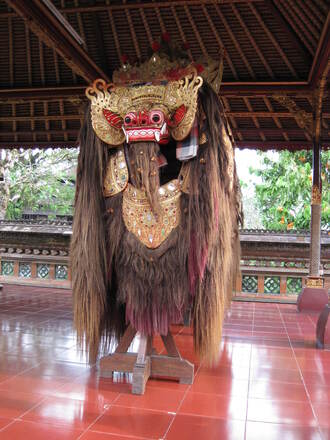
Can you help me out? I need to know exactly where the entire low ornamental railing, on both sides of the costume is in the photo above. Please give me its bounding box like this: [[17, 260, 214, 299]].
[[0, 221, 330, 302]]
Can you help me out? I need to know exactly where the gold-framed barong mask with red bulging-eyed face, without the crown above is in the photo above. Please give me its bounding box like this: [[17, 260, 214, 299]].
[[86, 67, 203, 146]]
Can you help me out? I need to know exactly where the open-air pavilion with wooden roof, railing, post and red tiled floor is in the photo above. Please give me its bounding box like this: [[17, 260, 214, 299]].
[[0, 0, 330, 440]]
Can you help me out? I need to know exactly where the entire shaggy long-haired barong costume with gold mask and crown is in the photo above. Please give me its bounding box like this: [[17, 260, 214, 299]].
[[71, 41, 241, 368]]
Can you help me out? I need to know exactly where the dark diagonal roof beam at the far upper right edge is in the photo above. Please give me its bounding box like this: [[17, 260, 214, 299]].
[[308, 12, 330, 89]]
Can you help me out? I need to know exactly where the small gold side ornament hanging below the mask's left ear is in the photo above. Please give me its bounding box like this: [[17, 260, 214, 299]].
[[103, 148, 128, 197]]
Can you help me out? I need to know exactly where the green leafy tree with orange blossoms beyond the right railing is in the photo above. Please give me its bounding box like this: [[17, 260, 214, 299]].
[[250, 151, 330, 230]]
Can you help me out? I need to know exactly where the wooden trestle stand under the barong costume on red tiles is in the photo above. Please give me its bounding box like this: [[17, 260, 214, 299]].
[[100, 326, 194, 394]]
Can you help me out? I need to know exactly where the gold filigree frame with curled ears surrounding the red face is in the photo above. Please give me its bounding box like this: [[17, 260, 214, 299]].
[[86, 68, 203, 146]]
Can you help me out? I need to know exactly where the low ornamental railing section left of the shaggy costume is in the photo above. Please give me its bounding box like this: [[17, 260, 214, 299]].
[[0, 220, 71, 288]]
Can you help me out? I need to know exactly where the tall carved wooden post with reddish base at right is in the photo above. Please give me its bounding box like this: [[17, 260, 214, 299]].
[[297, 63, 330, 311]]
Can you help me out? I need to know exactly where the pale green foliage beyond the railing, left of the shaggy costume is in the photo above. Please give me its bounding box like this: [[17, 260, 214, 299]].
[[1, 149, 78, 219]]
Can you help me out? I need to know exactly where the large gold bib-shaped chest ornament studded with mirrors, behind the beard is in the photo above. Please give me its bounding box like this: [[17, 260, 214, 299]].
[[123, 179, 181, 249]]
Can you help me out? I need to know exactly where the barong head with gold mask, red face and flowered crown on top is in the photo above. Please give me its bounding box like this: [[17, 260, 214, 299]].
[[86, 40, 221, 147]]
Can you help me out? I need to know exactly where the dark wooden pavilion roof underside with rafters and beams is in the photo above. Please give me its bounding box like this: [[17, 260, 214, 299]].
[[0, 0, 330, 149]]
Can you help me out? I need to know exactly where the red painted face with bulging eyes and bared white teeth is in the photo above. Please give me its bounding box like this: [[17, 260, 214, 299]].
[[122, 110, 170, 144]]
